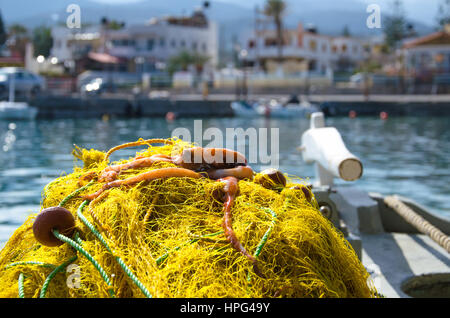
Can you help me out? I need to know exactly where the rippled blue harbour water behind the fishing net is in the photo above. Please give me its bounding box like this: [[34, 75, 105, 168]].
[[0, 117, 450, 246]]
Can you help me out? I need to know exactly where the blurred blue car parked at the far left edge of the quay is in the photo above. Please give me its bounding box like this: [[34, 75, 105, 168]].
[[0, 67, 45, 98]]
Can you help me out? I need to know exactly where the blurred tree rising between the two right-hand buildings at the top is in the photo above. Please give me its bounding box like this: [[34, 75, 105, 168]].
[[384, 0, 407, 50]]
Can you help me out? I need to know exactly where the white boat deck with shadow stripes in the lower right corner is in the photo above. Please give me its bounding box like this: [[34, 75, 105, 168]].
[[360, 232, 450, 298]]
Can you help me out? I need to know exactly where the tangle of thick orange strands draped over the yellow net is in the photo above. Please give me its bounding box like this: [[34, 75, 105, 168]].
[[36, 139, 285, 277]]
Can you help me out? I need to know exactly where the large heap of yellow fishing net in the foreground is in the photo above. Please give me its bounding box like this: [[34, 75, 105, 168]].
[[0, 139, 376, 298]]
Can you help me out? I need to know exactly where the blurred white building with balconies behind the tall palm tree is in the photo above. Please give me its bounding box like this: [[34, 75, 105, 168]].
[[246, 23, 365, 74]]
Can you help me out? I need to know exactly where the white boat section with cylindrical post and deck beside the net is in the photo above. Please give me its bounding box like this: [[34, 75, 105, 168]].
[[300, 112, 450, 298]]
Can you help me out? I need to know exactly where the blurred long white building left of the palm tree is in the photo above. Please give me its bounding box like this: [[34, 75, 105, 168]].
[[51, 9, 218, 72]]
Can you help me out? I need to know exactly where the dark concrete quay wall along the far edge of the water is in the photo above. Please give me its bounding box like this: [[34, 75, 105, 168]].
[[28, 94, 450, 119]]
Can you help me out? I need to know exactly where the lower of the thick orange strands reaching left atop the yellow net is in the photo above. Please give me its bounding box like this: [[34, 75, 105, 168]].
[[83, 167, 201, 200]]
